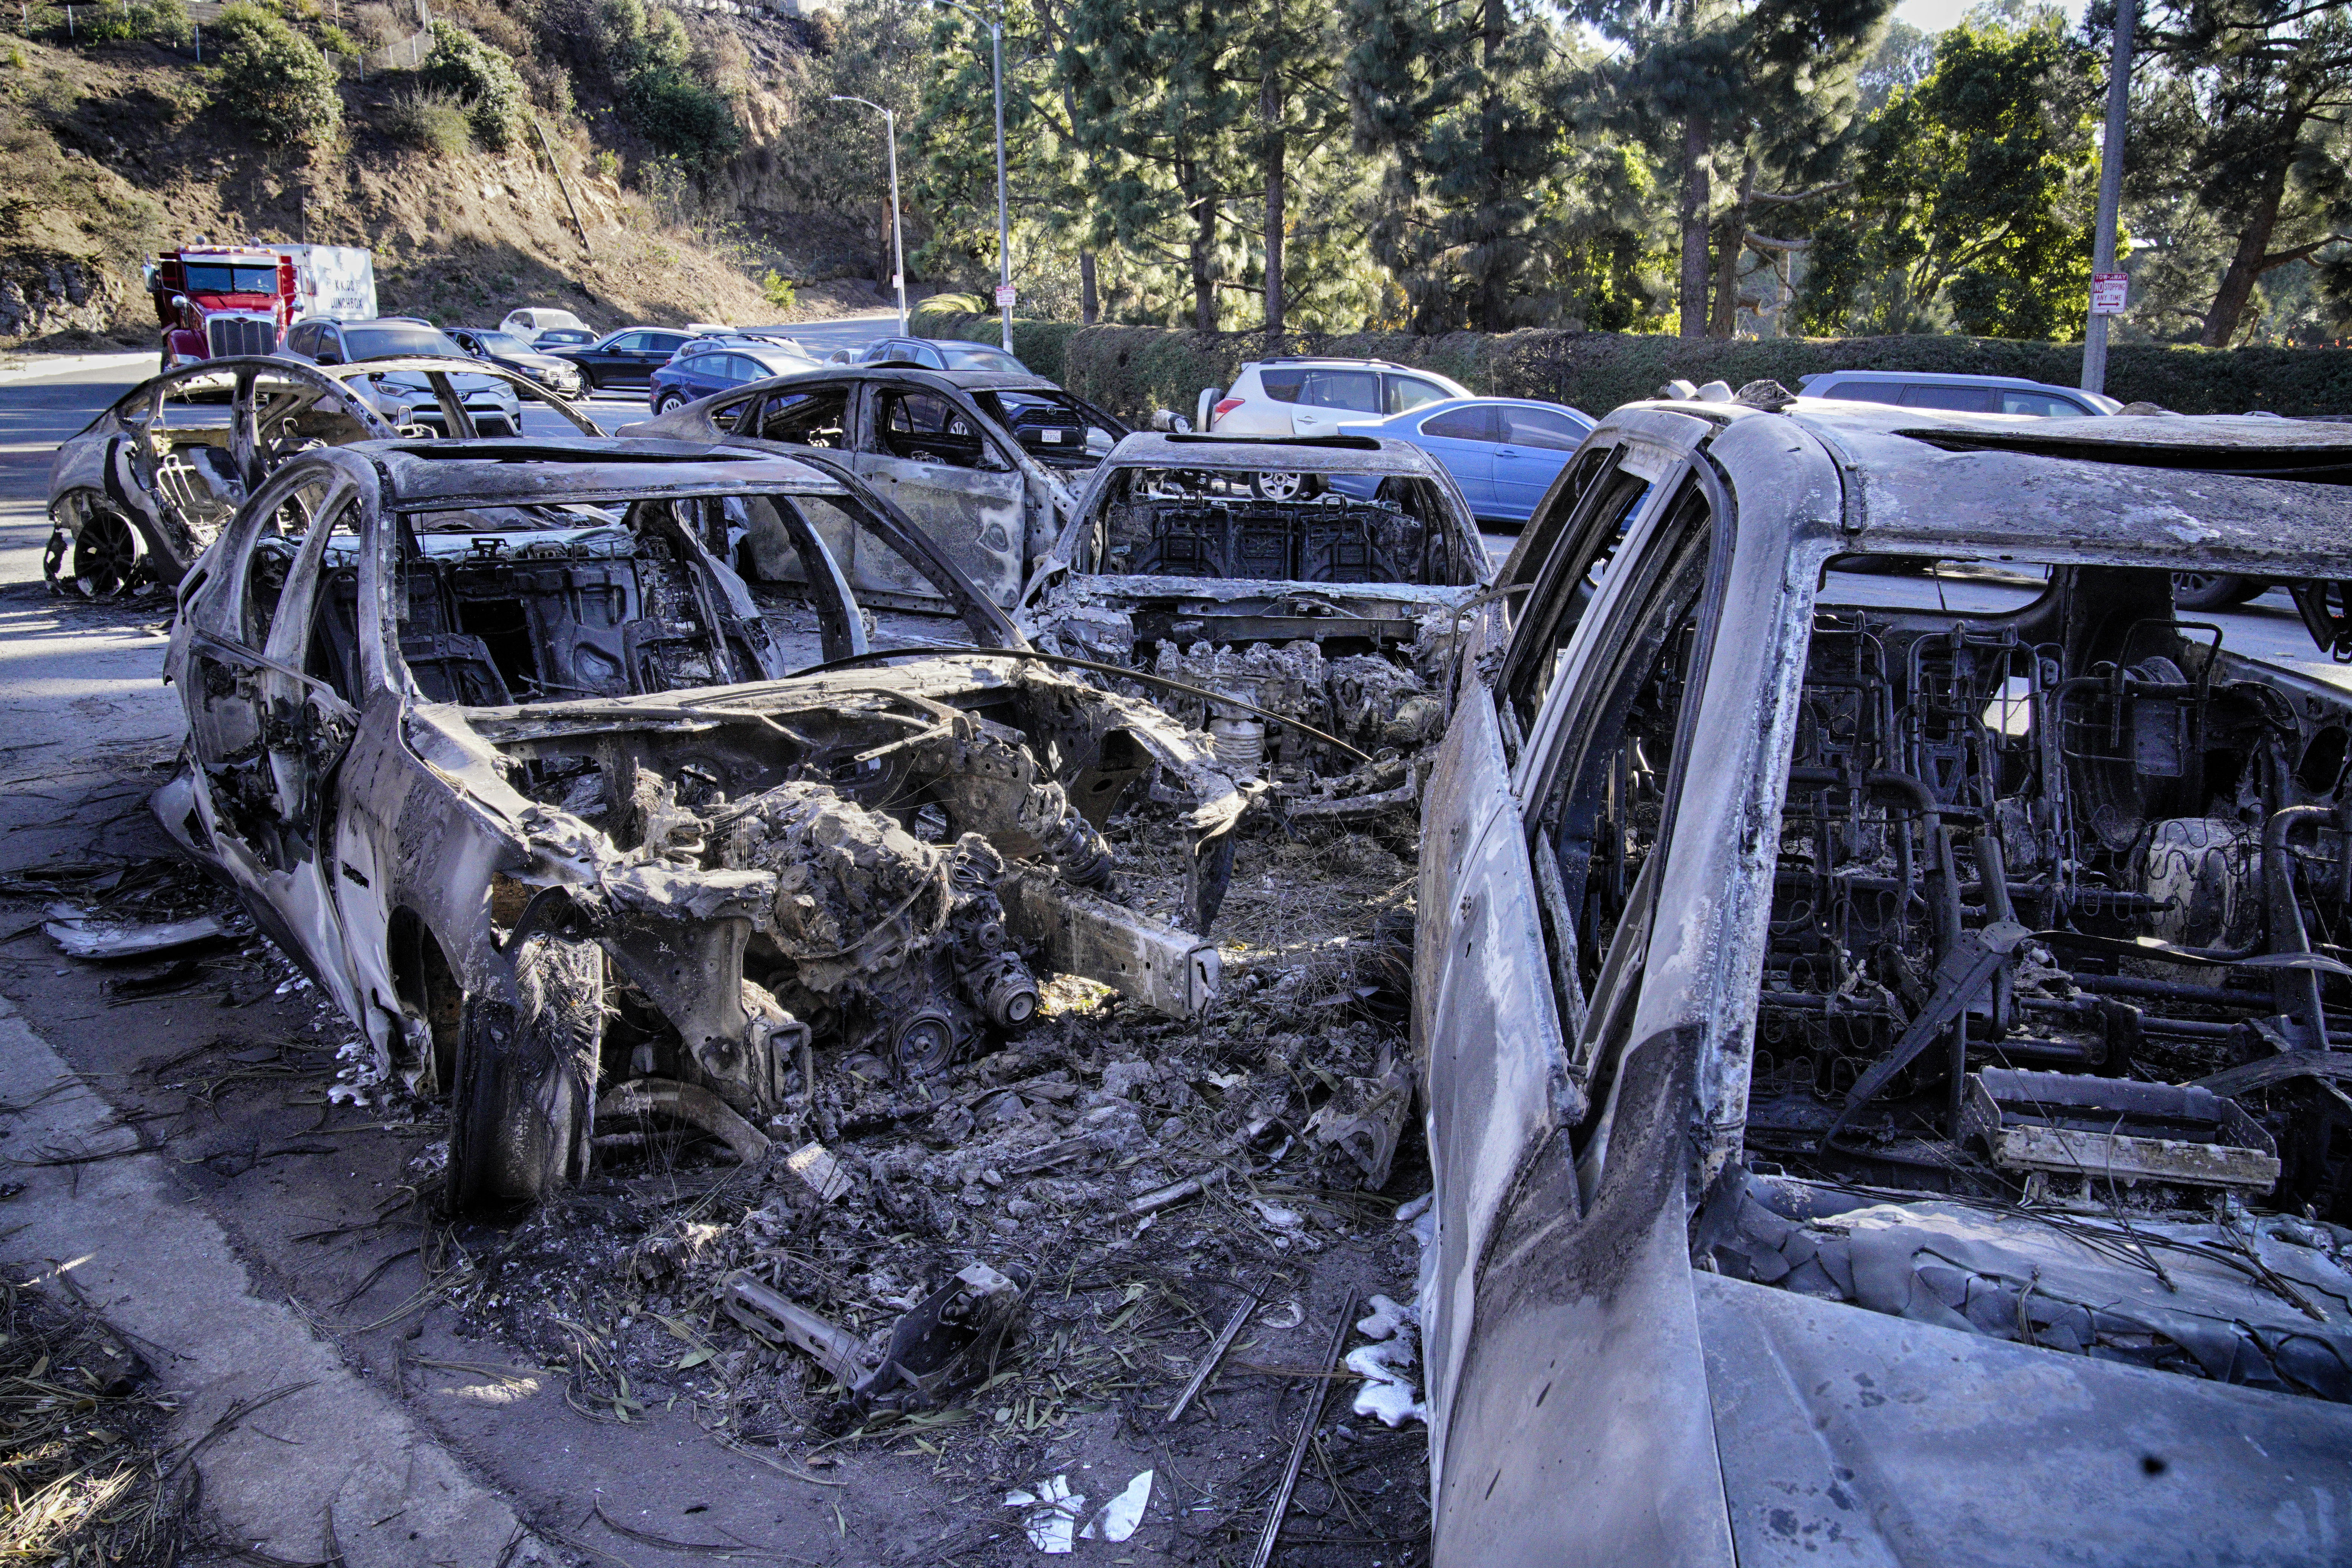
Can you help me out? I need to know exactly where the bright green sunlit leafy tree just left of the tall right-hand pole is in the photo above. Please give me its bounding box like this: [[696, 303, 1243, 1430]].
[[1799, 17, 2098, 338]]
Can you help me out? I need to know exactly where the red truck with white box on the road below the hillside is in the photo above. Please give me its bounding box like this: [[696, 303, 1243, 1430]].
[[146, 240, 376, 369]]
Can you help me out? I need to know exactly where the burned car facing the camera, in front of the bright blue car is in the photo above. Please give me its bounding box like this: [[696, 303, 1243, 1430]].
[[1018, 433, 1489, 816]]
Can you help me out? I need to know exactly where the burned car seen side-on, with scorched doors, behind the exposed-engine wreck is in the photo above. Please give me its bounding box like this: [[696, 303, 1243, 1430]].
[[621, 364, 1127, 609]]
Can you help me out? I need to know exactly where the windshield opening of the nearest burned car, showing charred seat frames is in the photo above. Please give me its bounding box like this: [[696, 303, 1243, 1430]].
[[1745, 552, 2352, 1251]]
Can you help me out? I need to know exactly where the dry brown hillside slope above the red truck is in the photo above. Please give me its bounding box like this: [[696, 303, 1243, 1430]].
[[0, 7, 880, 343]]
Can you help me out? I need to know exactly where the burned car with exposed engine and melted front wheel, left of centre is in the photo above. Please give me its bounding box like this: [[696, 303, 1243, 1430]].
[[158, 442, 1246, 1211]]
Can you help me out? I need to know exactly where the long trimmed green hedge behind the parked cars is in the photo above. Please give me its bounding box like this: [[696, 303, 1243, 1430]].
[[913, 296, 2352, 421]]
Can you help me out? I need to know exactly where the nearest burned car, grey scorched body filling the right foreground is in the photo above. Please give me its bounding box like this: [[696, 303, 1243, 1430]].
[[1413, 400, 2352, 1568]]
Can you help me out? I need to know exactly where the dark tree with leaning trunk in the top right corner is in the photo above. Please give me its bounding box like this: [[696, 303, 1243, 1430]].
[[2135, 0, 2352, 348]]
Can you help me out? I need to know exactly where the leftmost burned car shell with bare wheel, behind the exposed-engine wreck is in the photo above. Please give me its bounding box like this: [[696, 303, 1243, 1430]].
[[42, 355, 602, 599]]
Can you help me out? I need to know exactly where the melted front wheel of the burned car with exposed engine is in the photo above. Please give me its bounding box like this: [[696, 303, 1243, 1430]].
[[447, 938, 605, 1215]]
